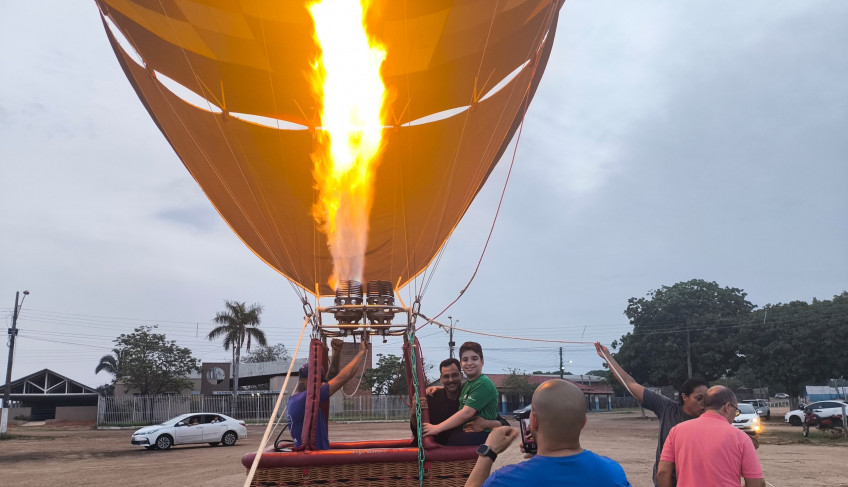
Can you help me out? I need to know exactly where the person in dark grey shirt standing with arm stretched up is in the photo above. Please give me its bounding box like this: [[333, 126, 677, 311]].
[[595, 343, 707, 485]]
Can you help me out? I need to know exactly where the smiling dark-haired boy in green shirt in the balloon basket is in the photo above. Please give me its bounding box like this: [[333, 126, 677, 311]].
[[422, 342, 498, 445]]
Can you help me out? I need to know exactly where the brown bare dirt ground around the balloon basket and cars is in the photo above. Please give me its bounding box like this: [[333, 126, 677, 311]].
[[0, 409, 848, 487]]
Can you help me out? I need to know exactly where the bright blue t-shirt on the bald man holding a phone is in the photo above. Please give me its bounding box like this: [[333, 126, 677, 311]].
[[483, 450, 630, 487]]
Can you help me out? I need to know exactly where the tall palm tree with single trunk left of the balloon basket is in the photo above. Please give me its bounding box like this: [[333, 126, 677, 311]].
[[206, 300, 268, 399]]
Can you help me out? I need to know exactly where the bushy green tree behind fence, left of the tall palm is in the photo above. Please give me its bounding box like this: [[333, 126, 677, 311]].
[[115, 326, 199, 396]]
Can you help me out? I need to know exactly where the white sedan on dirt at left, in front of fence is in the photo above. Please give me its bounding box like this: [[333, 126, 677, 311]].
[[132, 413, 247, 450]]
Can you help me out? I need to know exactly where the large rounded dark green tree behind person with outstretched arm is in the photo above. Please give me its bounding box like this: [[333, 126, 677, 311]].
[[612, 279, 754, 385]]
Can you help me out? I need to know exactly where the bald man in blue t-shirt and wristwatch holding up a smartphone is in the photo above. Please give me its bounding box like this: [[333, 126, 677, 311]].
[[465, 379, 630, 487]]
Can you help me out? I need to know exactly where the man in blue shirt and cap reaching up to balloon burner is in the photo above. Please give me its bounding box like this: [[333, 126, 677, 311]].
[[286, 338, 368, 450]]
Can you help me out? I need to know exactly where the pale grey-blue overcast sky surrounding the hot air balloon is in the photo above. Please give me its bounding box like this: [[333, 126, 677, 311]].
[[0, 0, 848, 387]]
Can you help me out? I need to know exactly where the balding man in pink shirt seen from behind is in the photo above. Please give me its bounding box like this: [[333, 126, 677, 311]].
[[657, 386, 766, 487]]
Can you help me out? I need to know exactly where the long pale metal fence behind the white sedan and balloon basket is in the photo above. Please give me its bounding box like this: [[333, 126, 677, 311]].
[[97, 394, 409, 426]]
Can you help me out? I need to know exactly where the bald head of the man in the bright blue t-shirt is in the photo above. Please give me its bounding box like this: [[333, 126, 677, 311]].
[[533, 379, 586, 441]]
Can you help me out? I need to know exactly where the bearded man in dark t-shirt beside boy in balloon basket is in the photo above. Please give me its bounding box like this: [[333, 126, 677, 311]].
[[409, 358, 509, 445]]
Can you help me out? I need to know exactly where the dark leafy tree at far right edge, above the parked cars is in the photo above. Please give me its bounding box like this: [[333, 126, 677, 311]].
[[738, 292, 848, 406]]
